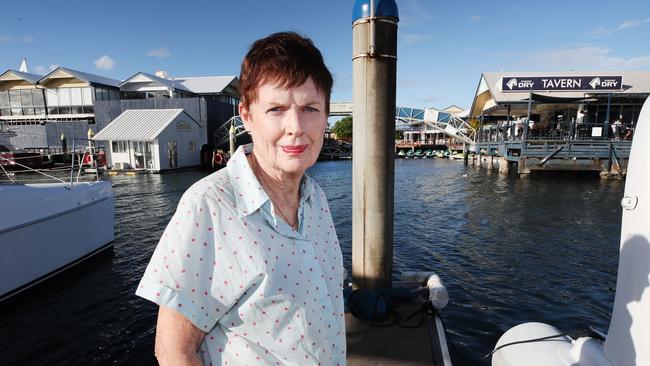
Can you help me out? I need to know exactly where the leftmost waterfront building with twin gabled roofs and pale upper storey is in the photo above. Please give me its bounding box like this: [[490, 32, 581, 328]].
[[0, 67, 120, 150]]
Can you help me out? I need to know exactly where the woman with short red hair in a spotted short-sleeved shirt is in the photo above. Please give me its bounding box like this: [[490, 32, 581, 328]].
[[136, 33, 345, 365]]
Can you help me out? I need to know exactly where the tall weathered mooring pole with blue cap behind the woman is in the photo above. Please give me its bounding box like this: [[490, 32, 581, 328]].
[[352, 0, 398, 289]]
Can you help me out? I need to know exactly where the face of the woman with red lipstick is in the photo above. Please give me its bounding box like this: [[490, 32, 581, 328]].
[[239, 78, 327, 179]]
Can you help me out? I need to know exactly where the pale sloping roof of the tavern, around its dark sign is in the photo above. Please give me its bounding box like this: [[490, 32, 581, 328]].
[[482, 71, 650, 103]]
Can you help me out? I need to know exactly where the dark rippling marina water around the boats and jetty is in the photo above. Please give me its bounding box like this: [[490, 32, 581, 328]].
[[0, 159, 624, 365]]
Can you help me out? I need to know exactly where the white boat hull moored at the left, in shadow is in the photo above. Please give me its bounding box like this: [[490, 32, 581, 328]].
[[0, 182, 115, 301]]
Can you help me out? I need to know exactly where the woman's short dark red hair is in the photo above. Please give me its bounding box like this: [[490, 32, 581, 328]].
[[239, 32, 333, 113]]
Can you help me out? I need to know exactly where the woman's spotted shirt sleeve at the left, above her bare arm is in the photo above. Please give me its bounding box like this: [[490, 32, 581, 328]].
[[136, 191, 239, 333]]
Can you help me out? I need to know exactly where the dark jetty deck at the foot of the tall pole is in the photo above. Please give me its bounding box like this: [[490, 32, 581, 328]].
[[345, 302, 451, 366]]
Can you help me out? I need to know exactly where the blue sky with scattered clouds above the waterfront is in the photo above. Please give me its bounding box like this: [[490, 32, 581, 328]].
[[0, 0, 650, 109]]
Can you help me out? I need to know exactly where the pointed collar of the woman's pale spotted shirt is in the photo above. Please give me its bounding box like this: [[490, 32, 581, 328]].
[[226, 144, 315, 217]]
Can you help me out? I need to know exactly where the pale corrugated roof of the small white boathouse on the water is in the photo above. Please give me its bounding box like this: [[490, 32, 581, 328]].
[[93, 109, 201, 141]]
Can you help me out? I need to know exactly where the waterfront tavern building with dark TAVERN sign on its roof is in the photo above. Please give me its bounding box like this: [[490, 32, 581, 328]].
[[469, 71, 650, 138]]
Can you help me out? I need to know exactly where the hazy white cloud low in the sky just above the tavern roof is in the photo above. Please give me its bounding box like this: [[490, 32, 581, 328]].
[[524, 46, 650, 71]]
